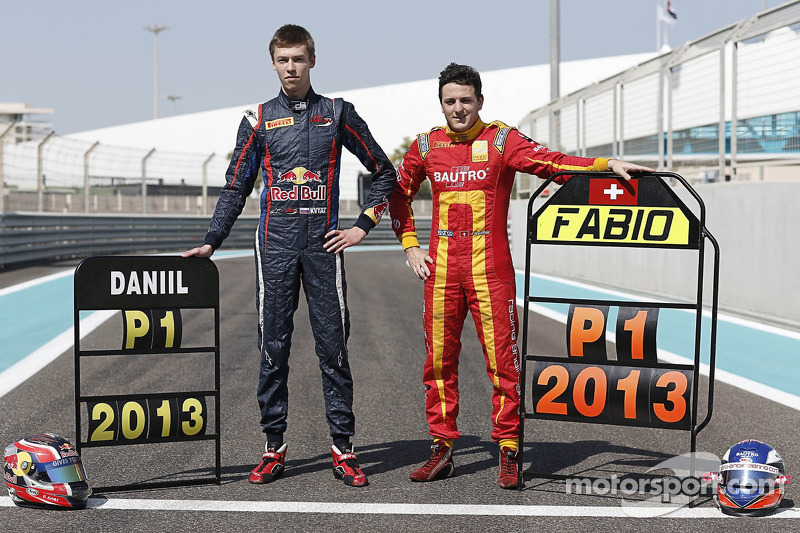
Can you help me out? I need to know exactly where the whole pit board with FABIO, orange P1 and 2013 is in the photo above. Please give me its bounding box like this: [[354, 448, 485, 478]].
[[517, 171, 719, 480]]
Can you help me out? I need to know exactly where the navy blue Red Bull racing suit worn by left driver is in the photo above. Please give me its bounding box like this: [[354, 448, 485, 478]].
[[205, 89, 396, 440]]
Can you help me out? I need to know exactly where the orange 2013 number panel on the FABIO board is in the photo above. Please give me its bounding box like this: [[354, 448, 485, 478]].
[[532, 358, 693, 429]]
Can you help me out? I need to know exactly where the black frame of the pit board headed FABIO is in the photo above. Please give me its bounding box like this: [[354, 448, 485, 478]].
[[517, 171, 720, 490]]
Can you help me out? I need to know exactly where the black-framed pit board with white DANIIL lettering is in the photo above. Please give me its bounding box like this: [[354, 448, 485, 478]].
[[74, 256, 222, 492]]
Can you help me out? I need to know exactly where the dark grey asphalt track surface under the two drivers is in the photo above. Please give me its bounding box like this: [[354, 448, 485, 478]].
[[0, 251, 800, 532]]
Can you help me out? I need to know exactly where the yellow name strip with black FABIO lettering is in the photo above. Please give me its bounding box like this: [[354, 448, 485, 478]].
[[537, 205, 689, 246]]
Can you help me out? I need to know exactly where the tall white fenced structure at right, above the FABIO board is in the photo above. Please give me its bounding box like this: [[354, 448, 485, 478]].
[[518, 2, 800, 194]]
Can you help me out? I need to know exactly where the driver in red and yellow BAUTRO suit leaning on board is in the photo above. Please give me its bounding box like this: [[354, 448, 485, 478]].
[[389, 64, 651, 488]]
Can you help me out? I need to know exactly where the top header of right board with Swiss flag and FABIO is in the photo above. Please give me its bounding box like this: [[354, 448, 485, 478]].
[[534, 175, 699, 248]]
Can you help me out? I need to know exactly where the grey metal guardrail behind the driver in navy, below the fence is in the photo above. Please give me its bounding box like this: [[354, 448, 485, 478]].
[[0, 212, 431, 269]]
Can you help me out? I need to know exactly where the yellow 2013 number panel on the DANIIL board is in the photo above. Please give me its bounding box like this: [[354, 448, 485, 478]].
[[87, 396, 208, 444]]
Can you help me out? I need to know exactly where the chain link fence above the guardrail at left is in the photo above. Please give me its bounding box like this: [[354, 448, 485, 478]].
[[0, 130, 241, 215]]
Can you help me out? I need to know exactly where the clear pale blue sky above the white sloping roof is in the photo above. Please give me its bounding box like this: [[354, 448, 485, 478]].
[[0, 0, 784, 134]]
